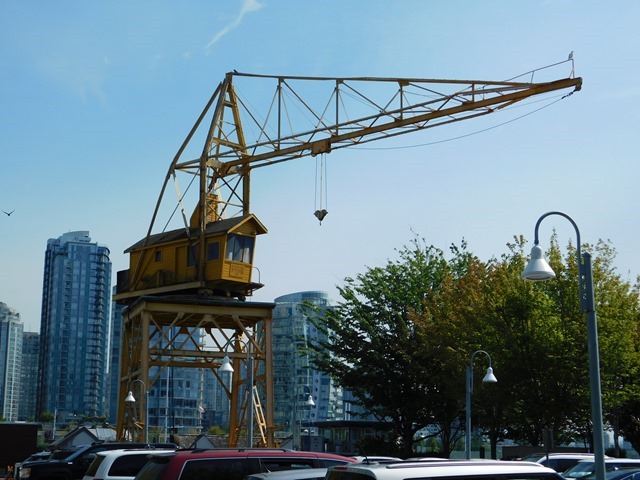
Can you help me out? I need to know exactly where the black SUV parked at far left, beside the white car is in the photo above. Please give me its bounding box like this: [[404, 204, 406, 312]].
[[20, 442, 177, 480]]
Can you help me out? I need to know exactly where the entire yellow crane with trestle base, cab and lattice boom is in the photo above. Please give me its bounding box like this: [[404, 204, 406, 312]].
[[114, 56, 582, 446]]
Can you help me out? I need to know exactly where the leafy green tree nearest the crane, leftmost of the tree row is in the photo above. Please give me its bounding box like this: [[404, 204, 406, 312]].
[[307, 238, 483, 456]]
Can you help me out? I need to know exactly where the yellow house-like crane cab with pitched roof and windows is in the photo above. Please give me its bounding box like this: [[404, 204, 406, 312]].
[[114, 214, 267, 303]]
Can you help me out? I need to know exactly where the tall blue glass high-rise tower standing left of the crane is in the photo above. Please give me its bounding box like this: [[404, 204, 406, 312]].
[[37, 231, 111, 417]]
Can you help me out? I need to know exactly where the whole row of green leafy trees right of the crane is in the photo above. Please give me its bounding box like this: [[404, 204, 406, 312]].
[[307, 234, 640, 456]]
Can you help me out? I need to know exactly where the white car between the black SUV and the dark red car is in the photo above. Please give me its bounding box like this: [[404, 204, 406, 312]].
[[83, 448, 175, 480]]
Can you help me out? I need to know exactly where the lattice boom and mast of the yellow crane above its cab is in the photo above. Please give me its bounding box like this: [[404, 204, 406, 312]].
[[149, 64, 582, 233]]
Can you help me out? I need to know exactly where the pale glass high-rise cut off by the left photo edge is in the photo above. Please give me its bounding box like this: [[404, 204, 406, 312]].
[[0, 302, 23, 421]]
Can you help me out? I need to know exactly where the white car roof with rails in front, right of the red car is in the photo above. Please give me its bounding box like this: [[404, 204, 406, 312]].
[[325, 460, 562, 480]]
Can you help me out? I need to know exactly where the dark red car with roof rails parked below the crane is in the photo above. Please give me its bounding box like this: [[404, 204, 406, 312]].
[[136, 448, 355, 480]]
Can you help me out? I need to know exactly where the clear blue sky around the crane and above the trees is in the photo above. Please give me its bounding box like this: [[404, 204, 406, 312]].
[[0, 0, 640, 331]]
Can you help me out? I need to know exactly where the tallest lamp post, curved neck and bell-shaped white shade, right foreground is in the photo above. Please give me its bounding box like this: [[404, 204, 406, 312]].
[[522, 212, 605, 480]]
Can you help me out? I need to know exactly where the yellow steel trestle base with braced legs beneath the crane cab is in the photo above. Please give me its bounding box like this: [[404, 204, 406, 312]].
[[116, 295, 275, 447]]
